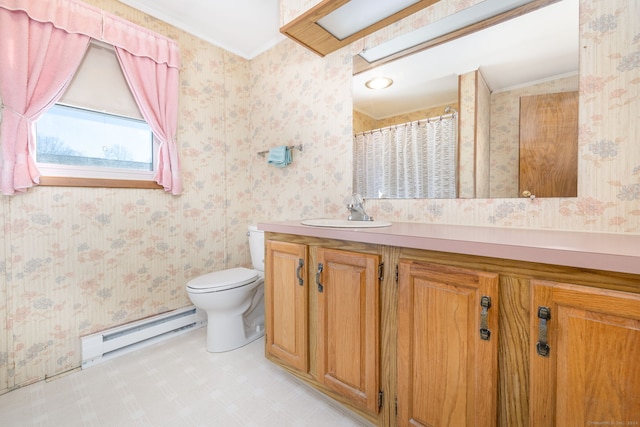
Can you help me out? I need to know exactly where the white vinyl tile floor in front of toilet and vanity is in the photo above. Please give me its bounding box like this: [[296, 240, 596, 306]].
[[0, 328, 372, 427]]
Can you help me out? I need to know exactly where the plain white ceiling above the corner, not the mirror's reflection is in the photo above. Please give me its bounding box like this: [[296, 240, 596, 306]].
[[119, 0, 285, 59]]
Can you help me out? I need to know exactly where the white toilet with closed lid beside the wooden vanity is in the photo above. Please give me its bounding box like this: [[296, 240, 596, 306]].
[[187, 226, 264, 353]]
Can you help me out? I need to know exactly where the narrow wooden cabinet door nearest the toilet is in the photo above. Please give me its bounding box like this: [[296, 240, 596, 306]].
[[265, 240, 309, 372]]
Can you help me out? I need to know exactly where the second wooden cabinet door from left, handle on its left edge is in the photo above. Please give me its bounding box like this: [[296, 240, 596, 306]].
[[316, 248, 380, 413]]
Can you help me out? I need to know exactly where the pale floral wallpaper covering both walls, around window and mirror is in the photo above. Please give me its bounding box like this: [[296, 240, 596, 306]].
[[0, 0, 640, 393]]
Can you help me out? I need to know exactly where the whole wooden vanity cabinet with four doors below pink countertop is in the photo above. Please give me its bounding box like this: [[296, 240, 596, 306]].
[[265, 233, 640, 427]]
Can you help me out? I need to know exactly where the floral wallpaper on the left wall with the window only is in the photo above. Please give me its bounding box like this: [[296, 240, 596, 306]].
[[0, 0, 255, 393]]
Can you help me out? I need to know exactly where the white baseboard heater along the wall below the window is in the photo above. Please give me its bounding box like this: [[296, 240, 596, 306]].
[[80, 306, 207, 369]]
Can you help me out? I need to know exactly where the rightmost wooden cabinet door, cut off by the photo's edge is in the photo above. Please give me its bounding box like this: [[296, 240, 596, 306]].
[[529, 281, 640, 427]]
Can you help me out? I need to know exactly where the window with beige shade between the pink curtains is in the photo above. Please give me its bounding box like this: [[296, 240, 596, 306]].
[[35, 42, 157, 188]]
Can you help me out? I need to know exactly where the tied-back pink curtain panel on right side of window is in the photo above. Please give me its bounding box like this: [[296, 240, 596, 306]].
[[116, 47, 182, 194]]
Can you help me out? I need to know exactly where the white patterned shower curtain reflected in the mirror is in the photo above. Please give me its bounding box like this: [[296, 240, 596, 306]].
[[353, 113, 458, 199]]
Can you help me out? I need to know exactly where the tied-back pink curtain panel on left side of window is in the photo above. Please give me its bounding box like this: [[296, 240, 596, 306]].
[[0, 8, 90, 195]]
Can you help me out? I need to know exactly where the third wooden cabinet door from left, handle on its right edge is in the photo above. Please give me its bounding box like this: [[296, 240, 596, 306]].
[[398, 260, 498, 426]]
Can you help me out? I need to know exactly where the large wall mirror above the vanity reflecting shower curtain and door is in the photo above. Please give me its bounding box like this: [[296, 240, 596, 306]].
[[353, 0, 579, 198]]
